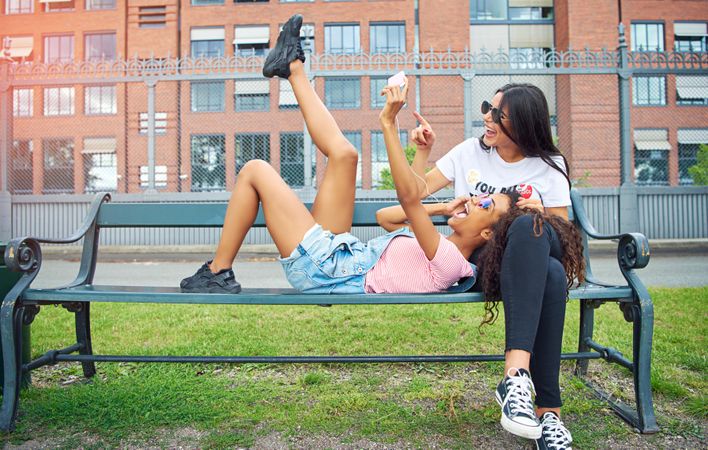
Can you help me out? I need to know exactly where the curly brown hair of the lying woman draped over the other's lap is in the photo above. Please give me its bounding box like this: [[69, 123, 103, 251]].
[[480, 192, 585, 325]]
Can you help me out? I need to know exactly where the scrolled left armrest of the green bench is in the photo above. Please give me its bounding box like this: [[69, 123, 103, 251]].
[[3, 193, 111, 285]]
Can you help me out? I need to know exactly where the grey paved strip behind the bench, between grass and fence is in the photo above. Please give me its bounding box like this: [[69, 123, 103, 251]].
[[33, 250, 708, 287]]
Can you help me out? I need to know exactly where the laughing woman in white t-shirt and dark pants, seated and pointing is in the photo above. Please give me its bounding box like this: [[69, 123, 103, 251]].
[[411, 84, 572, 448]]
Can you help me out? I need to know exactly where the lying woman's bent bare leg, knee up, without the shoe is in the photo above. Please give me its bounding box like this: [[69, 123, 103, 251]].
[[210, 160, 315, 273]]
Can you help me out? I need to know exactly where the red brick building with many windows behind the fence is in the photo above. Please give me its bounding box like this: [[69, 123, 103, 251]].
[[0, 0, 708, 194]]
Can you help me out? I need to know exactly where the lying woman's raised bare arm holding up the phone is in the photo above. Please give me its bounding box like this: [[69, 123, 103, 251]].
[[379, 80, 440, 260]]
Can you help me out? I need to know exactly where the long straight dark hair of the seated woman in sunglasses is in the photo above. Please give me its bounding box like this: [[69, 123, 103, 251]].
[[479, 83, 570, 187]]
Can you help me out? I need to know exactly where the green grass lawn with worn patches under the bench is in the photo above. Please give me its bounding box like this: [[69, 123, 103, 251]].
[[2, 287, 708, 448]]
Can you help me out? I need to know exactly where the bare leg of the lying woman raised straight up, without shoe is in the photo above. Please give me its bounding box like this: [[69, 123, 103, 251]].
[[288, 60, 359, 234]]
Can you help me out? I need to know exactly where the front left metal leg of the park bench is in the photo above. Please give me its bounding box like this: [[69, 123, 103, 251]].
[[0, 301, 24, 432]]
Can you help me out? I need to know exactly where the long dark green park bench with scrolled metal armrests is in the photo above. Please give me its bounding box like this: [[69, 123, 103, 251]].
[[0, 190, 658, 433]]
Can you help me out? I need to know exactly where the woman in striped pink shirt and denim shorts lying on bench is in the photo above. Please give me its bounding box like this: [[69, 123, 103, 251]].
[[181, 16, 515, 294]]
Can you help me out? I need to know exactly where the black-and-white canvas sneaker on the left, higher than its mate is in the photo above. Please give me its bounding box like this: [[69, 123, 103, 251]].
[[496, 368, 541, 439]]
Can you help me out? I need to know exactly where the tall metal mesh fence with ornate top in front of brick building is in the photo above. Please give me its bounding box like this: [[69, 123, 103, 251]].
[[0, 24, 708, 241]]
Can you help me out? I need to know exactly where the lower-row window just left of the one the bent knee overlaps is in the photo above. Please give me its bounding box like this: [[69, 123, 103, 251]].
[[192, 134, 226, 192]]
